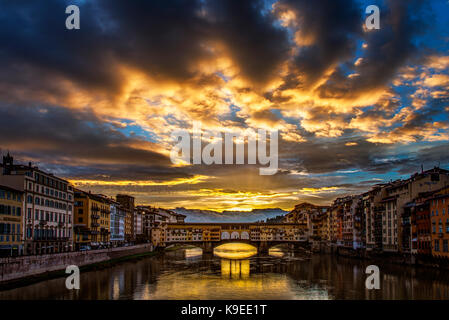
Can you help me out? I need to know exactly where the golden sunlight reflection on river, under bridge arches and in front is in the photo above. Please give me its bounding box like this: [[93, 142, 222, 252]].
[[145, 243, 329, 300]]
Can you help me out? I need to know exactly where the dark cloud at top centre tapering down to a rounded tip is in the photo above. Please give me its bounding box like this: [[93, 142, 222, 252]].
[[206, 0, 289, 82]]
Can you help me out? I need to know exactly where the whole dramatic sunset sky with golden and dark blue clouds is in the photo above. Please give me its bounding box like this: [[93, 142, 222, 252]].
[[0, 0, 449, 211]]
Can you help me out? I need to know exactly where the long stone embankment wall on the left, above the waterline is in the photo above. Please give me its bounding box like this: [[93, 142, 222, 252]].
[[0, 244, 153, 283]]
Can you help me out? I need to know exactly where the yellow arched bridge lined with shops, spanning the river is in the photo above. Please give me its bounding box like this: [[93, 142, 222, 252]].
[[164, 222, 308, 253]]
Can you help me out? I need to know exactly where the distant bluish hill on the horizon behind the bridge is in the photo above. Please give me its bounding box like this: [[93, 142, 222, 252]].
[[172, 208, 288, 222]]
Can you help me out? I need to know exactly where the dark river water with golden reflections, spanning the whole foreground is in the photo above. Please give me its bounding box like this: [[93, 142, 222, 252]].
[[0, 244, 449, 300]]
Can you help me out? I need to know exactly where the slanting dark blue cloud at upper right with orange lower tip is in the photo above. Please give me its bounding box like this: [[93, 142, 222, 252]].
[[320, 0, 432, 98]]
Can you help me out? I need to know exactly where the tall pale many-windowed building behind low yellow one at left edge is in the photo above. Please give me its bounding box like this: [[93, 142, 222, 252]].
[[0, 153, 73, 254]]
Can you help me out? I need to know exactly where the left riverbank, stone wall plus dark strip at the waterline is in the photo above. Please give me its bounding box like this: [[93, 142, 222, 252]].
[[0, 244, 160, 290]]
